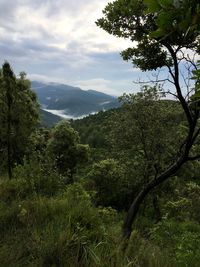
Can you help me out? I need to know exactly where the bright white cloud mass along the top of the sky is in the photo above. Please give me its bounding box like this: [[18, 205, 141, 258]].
[[1, 0, 130, 52]]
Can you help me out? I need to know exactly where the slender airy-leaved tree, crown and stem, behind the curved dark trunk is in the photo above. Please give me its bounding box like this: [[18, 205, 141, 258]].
[[108, 86, 185, 218]]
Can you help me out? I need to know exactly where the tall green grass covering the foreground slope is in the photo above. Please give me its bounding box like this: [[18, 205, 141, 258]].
[[0, 174, 188, 267]]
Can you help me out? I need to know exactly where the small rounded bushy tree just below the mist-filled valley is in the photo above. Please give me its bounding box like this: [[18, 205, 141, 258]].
[[47, 120, 89, 182]]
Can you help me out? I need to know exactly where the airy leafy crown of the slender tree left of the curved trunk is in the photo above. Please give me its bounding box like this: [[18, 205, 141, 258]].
[[109, 86, 183, 165]]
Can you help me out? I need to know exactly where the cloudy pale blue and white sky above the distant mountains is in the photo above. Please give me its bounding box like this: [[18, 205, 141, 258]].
[[0, 0, 147, 95]]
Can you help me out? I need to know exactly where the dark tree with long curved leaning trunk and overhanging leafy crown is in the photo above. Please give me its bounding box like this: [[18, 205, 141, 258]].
[[97, 0, 200, 238]]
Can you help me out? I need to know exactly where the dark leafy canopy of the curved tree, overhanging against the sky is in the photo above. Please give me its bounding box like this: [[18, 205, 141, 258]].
[[97, 0, 200, 71]]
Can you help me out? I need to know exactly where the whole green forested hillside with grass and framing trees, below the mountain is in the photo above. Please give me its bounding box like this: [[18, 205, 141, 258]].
[[0, 0, 200, 267]]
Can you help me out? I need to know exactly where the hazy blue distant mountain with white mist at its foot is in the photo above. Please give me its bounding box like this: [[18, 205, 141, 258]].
[[32, 81, 120, 118]]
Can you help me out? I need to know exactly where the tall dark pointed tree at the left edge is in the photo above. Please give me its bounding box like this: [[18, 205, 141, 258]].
[[0, 62, 39, 179]]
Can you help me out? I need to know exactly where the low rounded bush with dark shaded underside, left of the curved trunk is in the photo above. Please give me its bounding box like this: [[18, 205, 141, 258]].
[[85, 159, 132, 210]]
